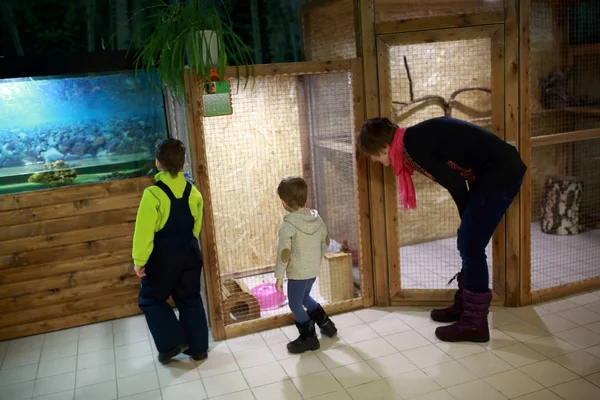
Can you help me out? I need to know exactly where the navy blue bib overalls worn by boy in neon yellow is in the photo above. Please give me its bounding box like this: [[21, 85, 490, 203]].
[[138, 181, 208, 354]]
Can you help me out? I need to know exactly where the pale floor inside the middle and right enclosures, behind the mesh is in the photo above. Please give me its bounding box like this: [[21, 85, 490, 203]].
[[400, 222, 600, 290]]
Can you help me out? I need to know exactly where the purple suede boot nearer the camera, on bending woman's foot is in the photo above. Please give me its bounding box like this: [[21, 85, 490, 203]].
[[435, 289, 492, 343]]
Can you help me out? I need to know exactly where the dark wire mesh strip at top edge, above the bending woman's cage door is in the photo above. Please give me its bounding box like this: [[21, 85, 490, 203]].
[[375, 0, 504, 22]]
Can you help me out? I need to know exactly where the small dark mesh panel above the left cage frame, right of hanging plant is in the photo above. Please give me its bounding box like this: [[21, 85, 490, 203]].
[[303, 0, 356, 61]]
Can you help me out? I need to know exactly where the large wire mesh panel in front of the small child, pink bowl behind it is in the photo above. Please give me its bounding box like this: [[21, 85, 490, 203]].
[[203, 72, 358, 325]]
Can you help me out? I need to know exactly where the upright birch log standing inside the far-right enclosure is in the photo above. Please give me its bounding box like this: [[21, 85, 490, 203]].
[[542, 176, 583, 235]]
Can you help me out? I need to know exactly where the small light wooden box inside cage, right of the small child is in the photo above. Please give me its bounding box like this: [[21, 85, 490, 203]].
[[319, 253, 354, 303]]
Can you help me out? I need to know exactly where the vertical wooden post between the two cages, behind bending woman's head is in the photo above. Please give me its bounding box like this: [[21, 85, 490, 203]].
[[355, 0, 396, 306]]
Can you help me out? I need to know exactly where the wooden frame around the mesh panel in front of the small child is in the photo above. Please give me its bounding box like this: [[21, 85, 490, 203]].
[[185, 59, 373, 340]]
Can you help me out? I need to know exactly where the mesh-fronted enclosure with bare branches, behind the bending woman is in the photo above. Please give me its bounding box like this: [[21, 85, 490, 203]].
[[377, 25, 504, 298]]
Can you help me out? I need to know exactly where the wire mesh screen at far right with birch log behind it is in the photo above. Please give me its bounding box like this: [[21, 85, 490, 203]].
[[530, 1, 600, 291]]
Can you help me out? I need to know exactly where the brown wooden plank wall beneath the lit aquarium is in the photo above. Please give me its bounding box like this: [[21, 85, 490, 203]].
[[0, 178, 153, 340]]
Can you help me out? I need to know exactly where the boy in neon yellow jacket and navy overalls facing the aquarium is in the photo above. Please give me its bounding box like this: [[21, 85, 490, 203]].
[[133, 139, 208, 364]]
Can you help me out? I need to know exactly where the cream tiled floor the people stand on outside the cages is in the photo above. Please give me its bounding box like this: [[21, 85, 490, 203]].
[[0, 291, 600, 400]]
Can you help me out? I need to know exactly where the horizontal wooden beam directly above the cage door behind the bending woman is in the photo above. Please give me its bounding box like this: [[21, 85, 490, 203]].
[[375, 12, 505, 35]]
